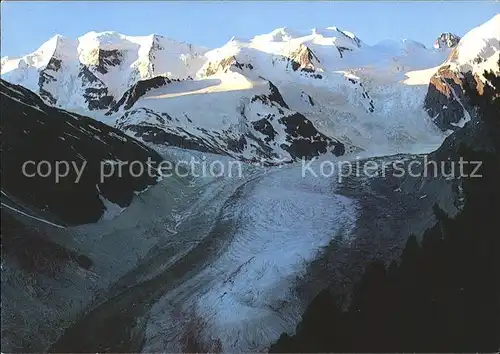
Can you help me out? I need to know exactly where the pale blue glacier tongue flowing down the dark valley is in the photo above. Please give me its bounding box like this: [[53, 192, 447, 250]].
[[143, 158, 356, 352]]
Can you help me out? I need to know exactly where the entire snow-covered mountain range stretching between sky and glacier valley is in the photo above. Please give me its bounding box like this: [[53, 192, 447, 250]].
[[2, 16, 499, 164]]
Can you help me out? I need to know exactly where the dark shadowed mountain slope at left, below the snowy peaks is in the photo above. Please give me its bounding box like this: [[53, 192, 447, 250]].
[[0, 80, 162, 225]]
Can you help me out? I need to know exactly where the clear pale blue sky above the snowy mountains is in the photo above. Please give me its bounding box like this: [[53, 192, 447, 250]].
[[1, 0, 500, 56]]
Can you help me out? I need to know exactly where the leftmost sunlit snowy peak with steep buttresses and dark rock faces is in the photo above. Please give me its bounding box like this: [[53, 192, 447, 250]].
[[1, 32, 206, 110]]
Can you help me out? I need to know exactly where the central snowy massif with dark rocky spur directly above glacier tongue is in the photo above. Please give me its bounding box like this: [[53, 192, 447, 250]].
[[101, 27, 449, 163]]
